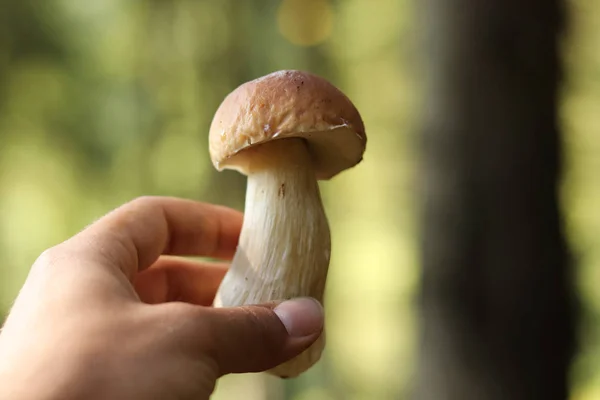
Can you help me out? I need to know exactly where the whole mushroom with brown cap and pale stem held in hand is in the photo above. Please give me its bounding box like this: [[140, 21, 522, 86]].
[[209, 70, 367, 378]]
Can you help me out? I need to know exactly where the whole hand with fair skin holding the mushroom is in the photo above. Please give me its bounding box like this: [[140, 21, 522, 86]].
[[0, 197, 323, 400]]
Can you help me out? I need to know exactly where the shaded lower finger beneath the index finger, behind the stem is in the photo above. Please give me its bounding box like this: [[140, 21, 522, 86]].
[[134, 256, 228, 306]]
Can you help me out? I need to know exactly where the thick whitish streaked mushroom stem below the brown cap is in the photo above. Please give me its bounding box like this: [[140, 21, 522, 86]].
[[215, 139, 331, 377]]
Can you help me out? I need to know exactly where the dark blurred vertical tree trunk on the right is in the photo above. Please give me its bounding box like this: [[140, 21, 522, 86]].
[[415, 0, 574, 400]]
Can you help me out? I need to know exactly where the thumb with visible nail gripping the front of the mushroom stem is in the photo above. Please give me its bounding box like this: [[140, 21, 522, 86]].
[[205, 298, 324, 375]]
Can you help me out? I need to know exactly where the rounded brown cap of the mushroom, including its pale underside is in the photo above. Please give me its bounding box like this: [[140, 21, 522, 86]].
[[209, 71, 367, 179]]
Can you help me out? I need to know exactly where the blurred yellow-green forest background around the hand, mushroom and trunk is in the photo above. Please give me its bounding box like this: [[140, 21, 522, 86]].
[[0, 0, 600, 400]]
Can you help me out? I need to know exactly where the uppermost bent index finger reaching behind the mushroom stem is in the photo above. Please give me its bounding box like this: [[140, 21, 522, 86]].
[[63, 197, 243, 279]]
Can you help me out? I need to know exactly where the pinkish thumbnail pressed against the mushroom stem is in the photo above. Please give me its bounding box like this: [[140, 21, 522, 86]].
[[273, 297, 324, 337]]
